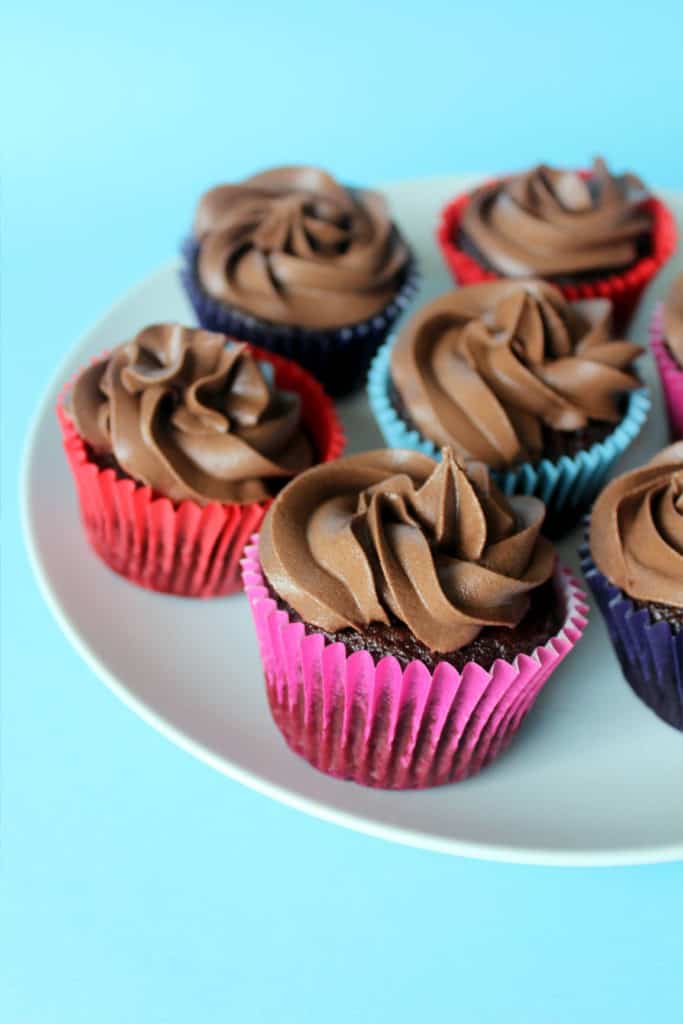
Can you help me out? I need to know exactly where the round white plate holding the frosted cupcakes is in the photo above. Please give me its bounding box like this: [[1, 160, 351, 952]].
[[23, 178, 683, 865]]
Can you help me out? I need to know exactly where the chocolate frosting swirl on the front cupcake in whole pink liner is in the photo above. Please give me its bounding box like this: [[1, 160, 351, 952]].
[[260, 450, 555, 653]]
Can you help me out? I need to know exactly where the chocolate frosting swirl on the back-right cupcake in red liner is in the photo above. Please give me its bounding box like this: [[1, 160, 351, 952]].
[[462, 159, 652, 278]]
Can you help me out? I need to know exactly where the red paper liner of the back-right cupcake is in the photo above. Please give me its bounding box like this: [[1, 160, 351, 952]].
[[436, 182, 677, 331]]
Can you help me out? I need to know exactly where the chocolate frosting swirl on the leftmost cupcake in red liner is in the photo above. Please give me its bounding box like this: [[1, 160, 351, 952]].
[[70, 324, 313, 505]]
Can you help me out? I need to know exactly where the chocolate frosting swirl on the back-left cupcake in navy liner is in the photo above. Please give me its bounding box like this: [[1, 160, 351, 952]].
[[195, 167, 410, 329]]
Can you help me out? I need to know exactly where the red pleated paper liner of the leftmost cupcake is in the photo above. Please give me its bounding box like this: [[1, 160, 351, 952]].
[[56, 346, 344, 597]]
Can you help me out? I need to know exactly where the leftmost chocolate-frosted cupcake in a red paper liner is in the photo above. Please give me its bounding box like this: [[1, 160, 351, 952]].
[[57, 324, 344, 597]]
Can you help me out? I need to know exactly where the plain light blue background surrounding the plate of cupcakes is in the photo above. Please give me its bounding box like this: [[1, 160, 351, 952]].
[[0, 0, 683, 1024]]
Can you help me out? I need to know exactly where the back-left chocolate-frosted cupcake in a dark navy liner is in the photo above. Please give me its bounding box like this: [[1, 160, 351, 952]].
[[182, 167, 416, 395]]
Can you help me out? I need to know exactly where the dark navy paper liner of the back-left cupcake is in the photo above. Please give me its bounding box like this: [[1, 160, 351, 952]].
[[180, 238, 419, 398]]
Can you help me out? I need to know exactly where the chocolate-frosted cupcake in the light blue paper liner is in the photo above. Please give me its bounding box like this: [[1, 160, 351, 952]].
[[369, 281, 649, 537]]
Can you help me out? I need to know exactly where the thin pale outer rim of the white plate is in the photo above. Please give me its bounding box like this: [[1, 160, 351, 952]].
[[19, 180, 683, 867]]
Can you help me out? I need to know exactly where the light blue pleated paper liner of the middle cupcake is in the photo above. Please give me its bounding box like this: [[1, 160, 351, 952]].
[[368, 338, 651, 538]]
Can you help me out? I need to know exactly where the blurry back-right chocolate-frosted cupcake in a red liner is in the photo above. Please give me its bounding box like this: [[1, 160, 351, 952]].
[[438, 159, 676, 330]]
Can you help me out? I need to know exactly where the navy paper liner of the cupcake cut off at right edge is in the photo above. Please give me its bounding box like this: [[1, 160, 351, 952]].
[[580, 544, 683, 730]]
